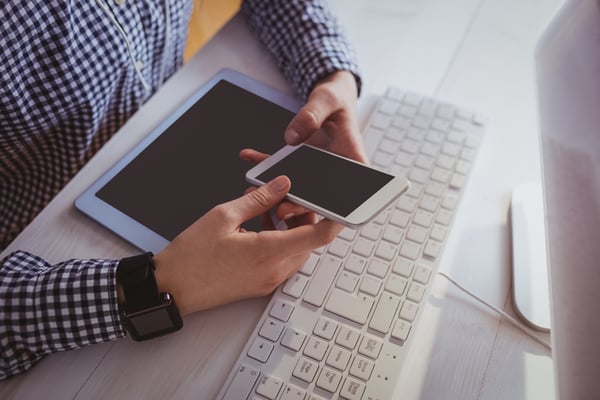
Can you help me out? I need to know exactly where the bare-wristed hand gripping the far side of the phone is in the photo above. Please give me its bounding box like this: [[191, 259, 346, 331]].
[[285, 71, 367, 162]]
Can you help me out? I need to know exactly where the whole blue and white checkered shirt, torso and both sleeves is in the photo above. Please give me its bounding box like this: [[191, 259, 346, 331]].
[[0, 0, 360, 379]]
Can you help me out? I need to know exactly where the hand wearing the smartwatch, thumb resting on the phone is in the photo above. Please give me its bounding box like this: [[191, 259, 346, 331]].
[[154, 176, 341, 315]]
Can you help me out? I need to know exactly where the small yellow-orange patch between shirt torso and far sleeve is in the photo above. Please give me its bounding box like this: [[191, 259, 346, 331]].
[[183, 0, 242, 62]]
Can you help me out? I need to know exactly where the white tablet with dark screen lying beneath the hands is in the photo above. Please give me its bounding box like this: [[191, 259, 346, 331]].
[[75, 69, 300, 253]]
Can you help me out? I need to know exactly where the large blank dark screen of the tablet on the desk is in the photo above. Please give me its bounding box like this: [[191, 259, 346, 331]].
[[95, 80, 294, 240]]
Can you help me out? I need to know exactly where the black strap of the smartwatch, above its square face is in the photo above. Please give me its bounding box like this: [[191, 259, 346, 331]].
[[117, 253, 162, 314]]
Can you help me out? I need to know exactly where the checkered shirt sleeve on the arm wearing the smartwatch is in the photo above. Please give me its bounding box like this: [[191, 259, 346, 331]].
[[0, 251, 125, 379]]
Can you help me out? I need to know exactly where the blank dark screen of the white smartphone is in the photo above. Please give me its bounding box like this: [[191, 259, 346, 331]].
[[257, 146, 394, 217]]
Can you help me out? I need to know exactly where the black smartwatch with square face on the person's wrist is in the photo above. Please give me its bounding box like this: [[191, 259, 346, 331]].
[[117, 253, 183, 341]]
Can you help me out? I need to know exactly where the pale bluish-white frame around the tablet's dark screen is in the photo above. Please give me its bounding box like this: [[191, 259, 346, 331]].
[[75, 68, 301, 254]]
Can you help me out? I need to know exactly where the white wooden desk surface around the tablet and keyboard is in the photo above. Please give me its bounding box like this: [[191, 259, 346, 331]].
[[0, 0, 561, 400]]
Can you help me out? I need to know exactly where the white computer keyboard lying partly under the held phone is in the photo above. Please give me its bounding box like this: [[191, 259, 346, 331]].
[[218, 88, 485, 400]]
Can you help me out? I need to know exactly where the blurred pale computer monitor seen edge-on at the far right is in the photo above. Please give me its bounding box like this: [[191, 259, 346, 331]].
[[536, 0, 600, 400]]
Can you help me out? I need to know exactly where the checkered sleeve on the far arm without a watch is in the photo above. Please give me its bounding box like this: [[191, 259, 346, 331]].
[[242, 0, 361, 100]]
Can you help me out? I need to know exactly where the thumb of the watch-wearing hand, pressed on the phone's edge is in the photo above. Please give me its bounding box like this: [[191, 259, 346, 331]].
[[229, 175, 292, 226]]
